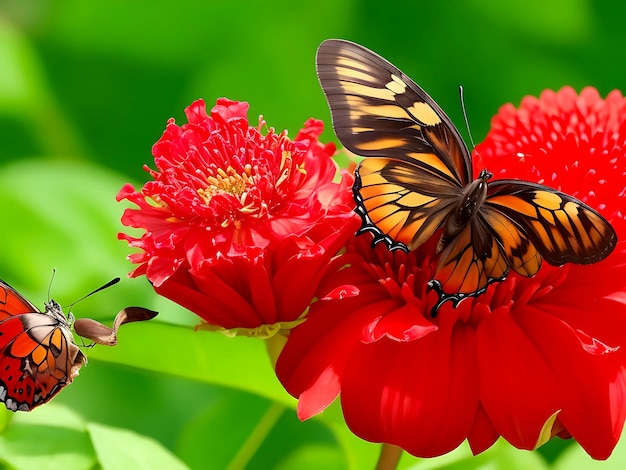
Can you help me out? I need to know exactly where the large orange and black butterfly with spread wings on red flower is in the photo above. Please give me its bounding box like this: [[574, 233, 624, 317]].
[[316, 39, 617, 316]]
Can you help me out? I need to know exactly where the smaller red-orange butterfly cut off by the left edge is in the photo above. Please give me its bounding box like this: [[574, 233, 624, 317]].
[[0, 278, 157, 411]]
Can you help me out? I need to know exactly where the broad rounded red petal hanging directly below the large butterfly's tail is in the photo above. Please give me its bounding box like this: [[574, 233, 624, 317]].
[[341, 312, 478, 457]]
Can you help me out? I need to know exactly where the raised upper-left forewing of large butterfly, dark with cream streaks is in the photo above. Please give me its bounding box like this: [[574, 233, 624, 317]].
[[317, 39, 471, 186]]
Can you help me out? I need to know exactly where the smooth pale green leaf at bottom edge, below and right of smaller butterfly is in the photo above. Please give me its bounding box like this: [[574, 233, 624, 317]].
[[87, 423, 188, 470]]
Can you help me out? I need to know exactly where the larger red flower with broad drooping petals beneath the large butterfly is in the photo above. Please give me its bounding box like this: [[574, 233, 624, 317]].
[[276, 88, 626, 459]]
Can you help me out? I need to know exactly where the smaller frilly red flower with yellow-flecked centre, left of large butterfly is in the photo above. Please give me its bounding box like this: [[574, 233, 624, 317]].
[[117, 98, 358, 334]]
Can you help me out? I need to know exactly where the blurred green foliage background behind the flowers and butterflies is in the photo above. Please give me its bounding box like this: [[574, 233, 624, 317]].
[[0, 0, 626, 469]]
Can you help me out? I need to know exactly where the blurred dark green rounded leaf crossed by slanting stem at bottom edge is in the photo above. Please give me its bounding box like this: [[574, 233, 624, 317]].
[[177, 393, 352, 470]]
